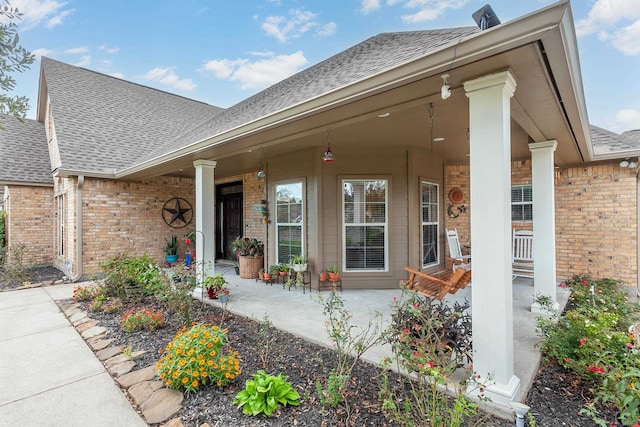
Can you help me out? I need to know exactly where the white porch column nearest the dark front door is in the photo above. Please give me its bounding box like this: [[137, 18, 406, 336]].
[[193, 160, 216, 284]]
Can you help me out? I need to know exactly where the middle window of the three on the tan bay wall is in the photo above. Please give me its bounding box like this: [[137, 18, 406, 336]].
[[342, 180, 388, 271]]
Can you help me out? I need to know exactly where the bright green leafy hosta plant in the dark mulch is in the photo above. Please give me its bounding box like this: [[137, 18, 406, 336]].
[[233, 370, 300, 417]]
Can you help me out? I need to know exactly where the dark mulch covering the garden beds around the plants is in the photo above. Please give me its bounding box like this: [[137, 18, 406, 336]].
[[0, 269, 613, 427]]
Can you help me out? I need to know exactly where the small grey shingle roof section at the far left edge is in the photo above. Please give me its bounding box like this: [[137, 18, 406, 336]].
[[0, 116, 53, 185]]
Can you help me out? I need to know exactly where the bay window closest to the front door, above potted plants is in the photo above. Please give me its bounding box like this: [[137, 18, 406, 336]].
[[276, 182, 304, 263]]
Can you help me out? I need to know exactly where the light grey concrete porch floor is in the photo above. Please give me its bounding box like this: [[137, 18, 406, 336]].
[[195, 266, 569, 412]]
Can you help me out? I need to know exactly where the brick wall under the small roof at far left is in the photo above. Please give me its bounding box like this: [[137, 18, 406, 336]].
[[5, 185, 53, 265]]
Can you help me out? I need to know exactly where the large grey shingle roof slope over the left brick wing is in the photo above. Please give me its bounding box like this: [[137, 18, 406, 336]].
[[41, 57, 223, 172]]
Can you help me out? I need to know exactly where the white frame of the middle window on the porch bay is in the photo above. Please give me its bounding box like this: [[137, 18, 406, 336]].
[[340, 177, 391, 273]]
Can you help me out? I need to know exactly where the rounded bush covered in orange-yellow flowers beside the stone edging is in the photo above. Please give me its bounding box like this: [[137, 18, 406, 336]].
[[156, 324, 242, 392]]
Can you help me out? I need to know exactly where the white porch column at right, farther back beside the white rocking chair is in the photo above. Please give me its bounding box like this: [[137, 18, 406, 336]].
[[529, 140, 558, 313]]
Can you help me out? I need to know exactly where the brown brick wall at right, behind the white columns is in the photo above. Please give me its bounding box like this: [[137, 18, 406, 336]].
[[444, 160, 638, 286]]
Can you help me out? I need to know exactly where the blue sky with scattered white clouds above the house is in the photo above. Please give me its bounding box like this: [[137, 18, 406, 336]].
[[11, 0, 640, 132]]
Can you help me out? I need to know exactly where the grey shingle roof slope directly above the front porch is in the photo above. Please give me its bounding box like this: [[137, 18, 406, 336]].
[[144, 27, 479, 164]]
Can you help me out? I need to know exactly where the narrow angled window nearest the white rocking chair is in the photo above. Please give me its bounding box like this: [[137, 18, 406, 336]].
[[421, 182, 440, 267]]
